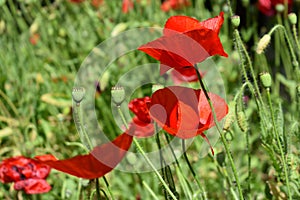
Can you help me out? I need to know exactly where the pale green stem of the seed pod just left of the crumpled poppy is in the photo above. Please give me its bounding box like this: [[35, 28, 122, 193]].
[[117, 106, 177, 200]]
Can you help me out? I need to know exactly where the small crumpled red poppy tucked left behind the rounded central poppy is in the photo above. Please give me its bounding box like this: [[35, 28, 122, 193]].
[[128, 97, 154, 138]]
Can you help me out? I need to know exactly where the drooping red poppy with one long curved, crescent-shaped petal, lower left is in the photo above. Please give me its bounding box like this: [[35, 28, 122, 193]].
[[36, 131, 134, 179]]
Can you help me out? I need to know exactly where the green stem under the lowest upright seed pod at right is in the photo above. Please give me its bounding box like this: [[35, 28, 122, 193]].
[[267, 88, 292, 200]]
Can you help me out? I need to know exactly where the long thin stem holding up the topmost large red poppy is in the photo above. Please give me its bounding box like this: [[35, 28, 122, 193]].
[[195, 66, 244, 199]]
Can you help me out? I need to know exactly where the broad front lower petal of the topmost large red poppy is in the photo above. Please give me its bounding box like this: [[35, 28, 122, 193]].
[[138, 28, 228, 73]]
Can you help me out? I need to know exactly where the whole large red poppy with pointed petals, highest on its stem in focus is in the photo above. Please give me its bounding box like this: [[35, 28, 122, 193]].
[[138, 12, 228, 74]]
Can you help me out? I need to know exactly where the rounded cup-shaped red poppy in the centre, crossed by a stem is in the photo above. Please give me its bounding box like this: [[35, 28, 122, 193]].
[[150, 86, 228, 139]]
